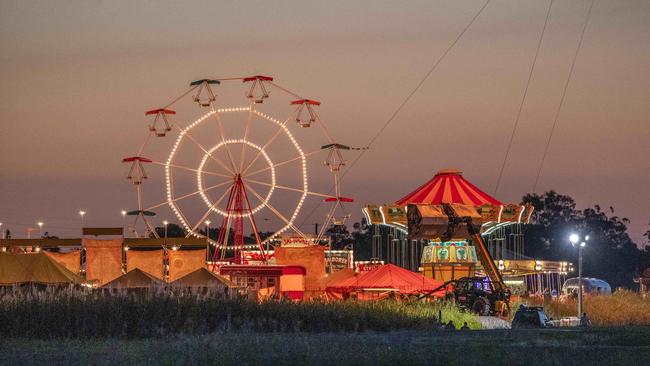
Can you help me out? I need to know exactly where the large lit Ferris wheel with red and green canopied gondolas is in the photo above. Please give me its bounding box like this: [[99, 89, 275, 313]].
[[123, 75, 352, 263]]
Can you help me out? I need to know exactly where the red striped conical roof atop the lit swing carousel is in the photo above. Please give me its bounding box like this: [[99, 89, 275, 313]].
[[395, 169, 501, 205]]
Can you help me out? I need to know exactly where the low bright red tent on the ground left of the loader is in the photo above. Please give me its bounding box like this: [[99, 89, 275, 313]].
[[327, 264, 445, 296]]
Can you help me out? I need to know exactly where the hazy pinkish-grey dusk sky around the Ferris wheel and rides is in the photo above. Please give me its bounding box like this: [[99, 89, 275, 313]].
[[0, 0, 650, 243]]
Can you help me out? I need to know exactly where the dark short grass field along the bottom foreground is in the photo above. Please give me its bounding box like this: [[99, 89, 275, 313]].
[[0, 327, 650, 366]]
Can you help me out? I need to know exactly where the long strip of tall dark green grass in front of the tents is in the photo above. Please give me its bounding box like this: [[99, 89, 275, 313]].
[[0, 289, 480, 339]]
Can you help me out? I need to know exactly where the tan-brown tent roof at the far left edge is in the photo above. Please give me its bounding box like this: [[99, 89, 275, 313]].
[[0, 253, 84, 285]]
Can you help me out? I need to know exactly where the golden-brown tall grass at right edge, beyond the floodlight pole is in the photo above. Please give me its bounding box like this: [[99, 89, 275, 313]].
[[522, 290, 650, 326]]
